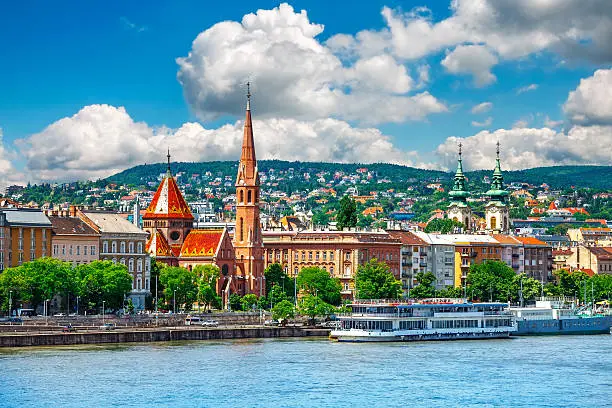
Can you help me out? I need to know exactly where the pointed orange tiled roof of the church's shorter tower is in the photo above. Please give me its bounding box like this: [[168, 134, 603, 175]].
[[142, 174, 193, 220]]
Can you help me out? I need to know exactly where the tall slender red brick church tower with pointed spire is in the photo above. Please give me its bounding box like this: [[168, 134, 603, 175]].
[[233, 83, 265, 296]]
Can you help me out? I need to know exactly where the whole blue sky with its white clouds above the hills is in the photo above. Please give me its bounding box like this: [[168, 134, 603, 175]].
[[0, 0, 612, 181]]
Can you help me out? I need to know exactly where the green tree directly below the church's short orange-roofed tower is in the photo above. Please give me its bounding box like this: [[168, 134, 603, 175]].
[[159, 266, 198, 311]]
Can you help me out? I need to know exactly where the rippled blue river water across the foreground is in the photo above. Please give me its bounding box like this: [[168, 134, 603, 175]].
[[0, 335, 612, 408]]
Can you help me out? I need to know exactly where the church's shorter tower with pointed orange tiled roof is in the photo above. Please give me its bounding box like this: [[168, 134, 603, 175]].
[[142, 150, 194, 266]]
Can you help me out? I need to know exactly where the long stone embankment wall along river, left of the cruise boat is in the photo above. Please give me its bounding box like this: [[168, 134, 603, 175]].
[[0, 327, 329, 347]]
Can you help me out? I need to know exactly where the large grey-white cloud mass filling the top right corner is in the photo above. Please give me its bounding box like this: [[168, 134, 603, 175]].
[[328, 0, 612, 85]]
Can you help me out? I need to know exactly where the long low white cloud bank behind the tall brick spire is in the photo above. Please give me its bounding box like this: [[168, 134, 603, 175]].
[[15, 105, 430, 181]]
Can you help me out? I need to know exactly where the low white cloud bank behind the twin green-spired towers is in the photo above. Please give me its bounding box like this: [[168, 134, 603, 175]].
[[436, 126, 612, 170]]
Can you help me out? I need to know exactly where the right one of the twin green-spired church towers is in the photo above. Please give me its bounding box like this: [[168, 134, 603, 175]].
[[485, 141, 510, 234]]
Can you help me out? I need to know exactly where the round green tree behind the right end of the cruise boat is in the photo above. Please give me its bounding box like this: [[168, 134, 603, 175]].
[[467, 261, 516, 301]]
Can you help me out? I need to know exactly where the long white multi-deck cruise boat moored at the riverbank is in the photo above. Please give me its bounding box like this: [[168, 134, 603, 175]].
[[329, 299, 516, 342]]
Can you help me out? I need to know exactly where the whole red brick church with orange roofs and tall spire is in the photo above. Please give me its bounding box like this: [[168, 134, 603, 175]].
[[142, 93, 265, 303]]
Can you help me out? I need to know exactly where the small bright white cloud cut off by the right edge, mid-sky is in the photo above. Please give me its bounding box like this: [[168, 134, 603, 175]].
[[563, 69, 612, 124]]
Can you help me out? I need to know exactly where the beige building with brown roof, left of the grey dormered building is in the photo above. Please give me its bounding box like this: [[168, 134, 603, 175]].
[[49, 214, 100, 266]]
